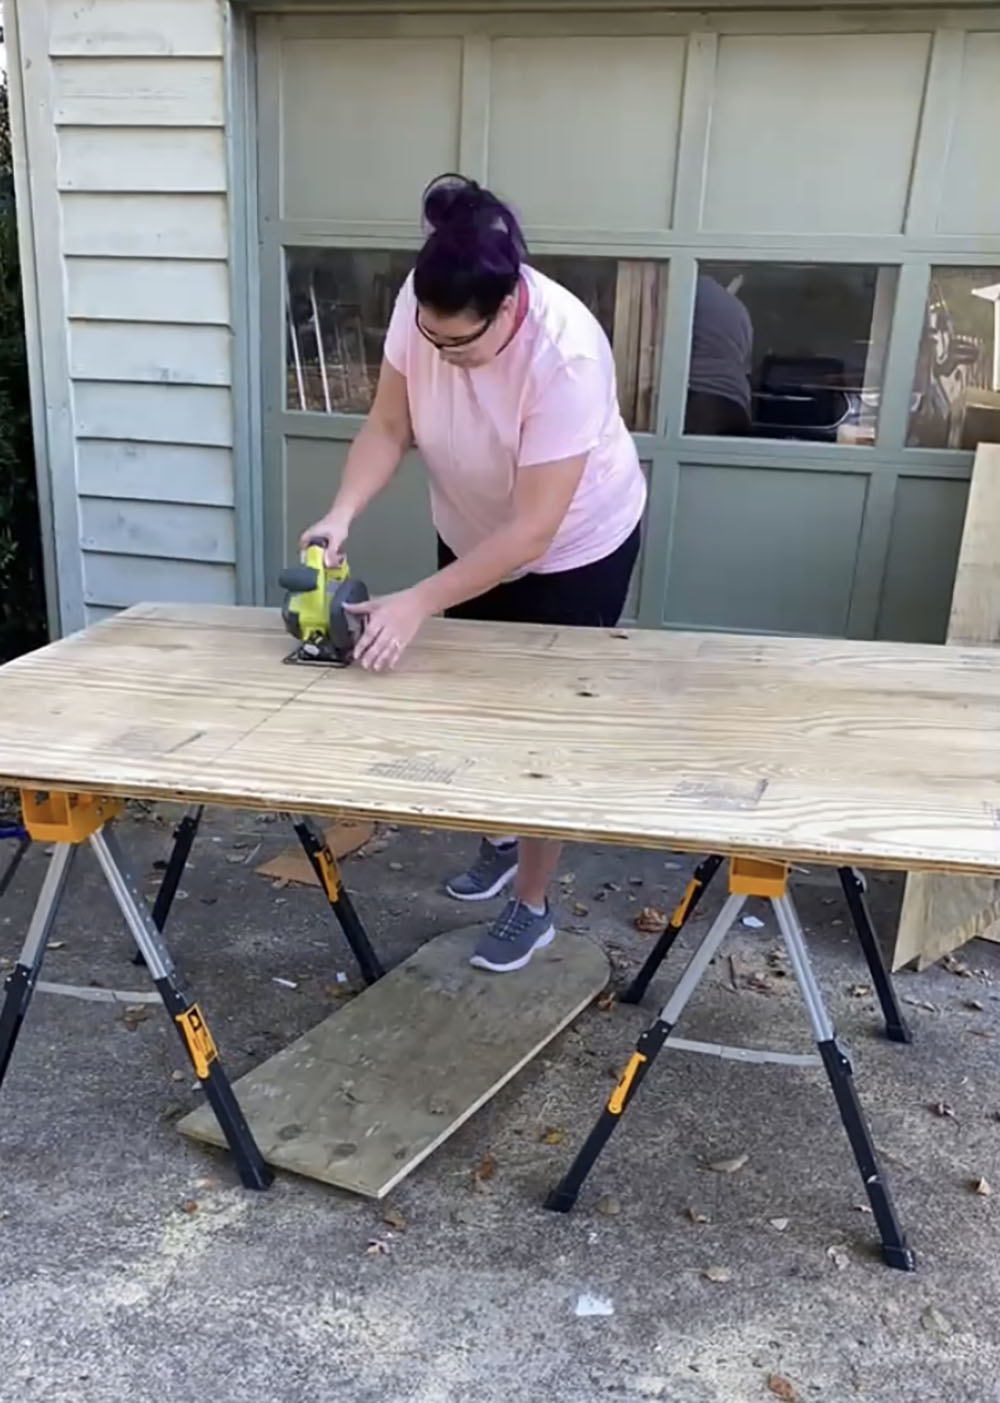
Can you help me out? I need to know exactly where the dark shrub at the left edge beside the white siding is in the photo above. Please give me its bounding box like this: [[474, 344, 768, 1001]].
[[0, 64, 45, 662]]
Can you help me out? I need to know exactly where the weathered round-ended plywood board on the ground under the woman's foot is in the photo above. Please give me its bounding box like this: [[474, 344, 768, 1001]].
[[178, 929, 607, 1198]]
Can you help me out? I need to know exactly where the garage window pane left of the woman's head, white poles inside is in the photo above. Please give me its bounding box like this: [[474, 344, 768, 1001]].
[[285, 248, 414, 414]]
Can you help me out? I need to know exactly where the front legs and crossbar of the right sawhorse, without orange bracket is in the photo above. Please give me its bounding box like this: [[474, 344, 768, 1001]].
[[546, 875, 916, 1271]]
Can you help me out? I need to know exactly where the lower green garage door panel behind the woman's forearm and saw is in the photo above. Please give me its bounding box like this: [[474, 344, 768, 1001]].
[[285, 438, 436, 593]]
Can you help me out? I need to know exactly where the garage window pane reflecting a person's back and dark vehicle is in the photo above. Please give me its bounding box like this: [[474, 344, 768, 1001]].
[[684, 262, 898, 445]]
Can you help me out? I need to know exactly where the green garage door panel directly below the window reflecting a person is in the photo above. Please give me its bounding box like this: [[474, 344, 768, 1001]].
[[665, 463, 867, 636]]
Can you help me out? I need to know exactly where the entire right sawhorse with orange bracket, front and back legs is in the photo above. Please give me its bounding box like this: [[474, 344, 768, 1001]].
[[546, 857, 916, 1271]]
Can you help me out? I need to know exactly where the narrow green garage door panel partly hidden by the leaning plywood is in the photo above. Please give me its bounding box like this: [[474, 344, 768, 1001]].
[[875, 477, 969, 643]]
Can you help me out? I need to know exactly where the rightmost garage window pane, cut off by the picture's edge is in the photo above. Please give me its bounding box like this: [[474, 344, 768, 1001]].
[[906, 267, 1000, 448]]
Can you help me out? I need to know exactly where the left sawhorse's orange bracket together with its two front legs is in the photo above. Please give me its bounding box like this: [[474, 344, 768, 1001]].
[[0, 791, 273, 1188]]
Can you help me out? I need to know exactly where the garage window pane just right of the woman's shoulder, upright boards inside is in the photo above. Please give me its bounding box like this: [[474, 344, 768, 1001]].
[[532, 255, 668, 434]]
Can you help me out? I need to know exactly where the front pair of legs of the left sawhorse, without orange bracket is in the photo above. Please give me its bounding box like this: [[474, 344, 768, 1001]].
[[0, 821, 273, 1188]]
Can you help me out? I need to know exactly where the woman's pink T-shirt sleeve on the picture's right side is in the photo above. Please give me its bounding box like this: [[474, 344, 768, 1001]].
[[518, 356, 609, 467]]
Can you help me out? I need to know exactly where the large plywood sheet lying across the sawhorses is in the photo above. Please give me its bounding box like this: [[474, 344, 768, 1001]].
[[0, 605, 1000, 875]]
